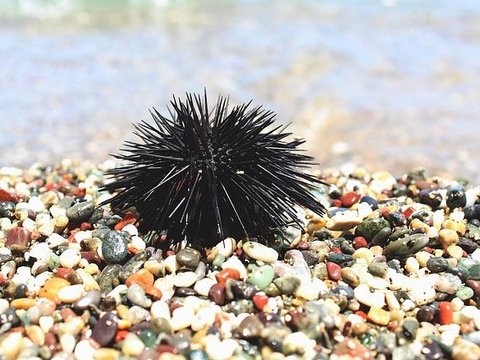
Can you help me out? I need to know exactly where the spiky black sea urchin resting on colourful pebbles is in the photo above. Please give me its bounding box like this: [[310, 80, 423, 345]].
[[104, 94, 325, 246]]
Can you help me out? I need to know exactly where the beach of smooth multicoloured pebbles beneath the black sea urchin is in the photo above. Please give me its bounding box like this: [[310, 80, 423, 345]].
[[0, 160, 480, 360]]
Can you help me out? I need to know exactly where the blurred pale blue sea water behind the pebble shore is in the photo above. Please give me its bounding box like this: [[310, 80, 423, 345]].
[[0, 0, 480, 182]]
